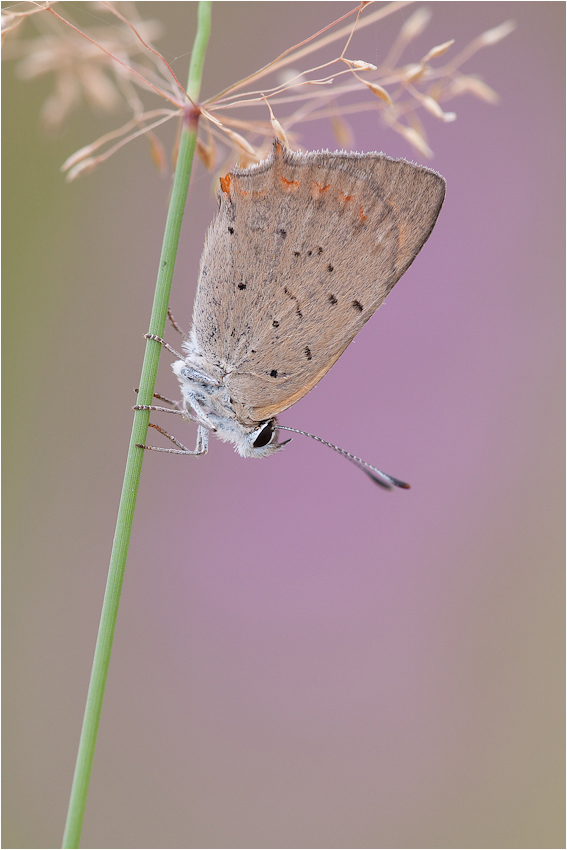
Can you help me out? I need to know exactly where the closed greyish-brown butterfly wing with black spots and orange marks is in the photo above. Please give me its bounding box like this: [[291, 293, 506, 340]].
[[193, 141, 445, 423]]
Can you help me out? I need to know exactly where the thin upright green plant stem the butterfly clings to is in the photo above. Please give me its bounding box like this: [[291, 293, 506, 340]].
[[63, 0, 211, 847]]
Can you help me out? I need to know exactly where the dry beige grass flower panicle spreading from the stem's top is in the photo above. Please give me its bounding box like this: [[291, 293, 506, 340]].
[[3, 2, 515, 180]]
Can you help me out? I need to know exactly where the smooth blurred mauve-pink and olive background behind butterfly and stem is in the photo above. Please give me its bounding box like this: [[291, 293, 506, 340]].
[[3, 2, 565, 848]]
